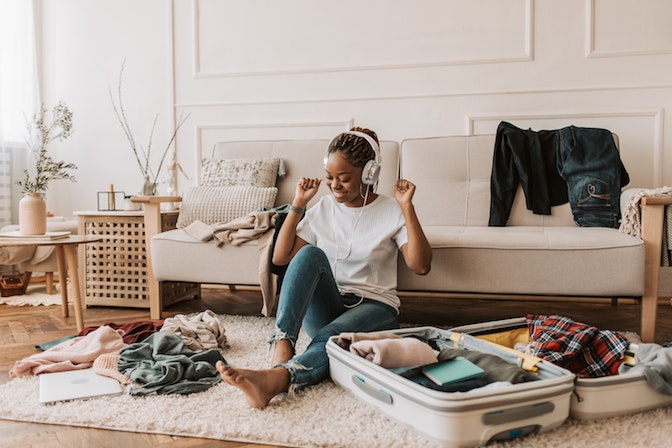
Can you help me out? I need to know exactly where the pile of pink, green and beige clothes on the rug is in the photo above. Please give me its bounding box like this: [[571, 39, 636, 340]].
[[9, 310, 227, 395]]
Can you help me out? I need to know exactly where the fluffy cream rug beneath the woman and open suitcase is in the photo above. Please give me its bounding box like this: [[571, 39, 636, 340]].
[[0, 316, 672, 448]]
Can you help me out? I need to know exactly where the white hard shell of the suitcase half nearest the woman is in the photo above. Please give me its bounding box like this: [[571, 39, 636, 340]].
[[327, 327, 574, 447]]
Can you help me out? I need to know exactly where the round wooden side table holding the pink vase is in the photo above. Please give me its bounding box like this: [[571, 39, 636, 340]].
[[0, 235, 101, 332]]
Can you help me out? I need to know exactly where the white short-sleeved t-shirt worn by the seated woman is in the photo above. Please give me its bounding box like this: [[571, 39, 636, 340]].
[[296, 195, 408, 309]]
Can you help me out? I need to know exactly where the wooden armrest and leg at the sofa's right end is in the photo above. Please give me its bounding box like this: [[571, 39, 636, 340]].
[[640, 195, 672, 342]]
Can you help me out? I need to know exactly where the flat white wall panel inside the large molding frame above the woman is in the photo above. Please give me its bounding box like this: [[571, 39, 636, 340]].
[[192, 0, 532, 76]]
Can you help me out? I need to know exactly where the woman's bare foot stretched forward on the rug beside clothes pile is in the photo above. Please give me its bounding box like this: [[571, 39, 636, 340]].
[[216, 361, 290, 409]]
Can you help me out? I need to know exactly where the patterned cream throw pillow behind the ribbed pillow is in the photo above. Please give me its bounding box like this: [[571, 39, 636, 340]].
[[201, 158, 280, 187]]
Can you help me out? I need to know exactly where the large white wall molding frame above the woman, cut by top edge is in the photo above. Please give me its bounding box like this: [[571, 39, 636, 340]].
[[192, 0, 535, 79]]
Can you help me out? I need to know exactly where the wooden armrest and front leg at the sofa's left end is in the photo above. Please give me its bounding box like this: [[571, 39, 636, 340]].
[[131, 196, 182, 320]]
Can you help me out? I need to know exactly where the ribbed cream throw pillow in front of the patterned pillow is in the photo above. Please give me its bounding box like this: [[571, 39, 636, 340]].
[[176, 185, 278, 229]]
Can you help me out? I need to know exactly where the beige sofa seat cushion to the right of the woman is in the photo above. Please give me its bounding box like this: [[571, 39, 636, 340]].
[[398, 226, 644, 297]]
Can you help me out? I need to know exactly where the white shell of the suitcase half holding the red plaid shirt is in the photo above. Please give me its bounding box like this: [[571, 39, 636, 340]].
[[452, 317, 672, 420]]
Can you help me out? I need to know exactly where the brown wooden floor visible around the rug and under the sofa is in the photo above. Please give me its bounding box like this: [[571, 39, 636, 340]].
[[0, 288, 672, 448]]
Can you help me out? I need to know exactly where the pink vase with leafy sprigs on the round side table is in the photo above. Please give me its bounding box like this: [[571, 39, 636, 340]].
[[17, 101, 77, 235]]
